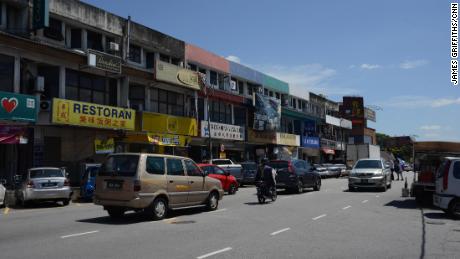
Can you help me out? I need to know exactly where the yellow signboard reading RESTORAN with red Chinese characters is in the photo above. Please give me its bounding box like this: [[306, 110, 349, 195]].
[[52, 98, 136, 130]]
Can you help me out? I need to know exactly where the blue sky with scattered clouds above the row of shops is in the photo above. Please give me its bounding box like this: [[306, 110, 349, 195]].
[[85, 0, 460, 142]]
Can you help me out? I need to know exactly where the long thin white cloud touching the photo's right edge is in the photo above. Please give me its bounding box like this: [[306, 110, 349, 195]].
[[377, 95, 460, 108]]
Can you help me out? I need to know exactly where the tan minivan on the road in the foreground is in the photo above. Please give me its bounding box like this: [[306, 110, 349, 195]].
[[93, 153, 224, 220]]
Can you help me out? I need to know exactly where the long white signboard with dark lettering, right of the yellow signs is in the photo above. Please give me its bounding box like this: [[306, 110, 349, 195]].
[[201, 121, 244, 141]]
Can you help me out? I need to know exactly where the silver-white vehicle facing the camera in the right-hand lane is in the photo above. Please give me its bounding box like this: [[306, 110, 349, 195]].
[[348, 158, 391, 192]]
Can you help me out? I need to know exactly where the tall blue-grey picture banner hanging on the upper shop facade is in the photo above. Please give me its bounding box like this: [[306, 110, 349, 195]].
[[253, 93, 281, 131]]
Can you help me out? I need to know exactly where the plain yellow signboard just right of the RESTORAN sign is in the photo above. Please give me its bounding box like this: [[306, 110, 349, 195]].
[[140, 112, 198, 136]]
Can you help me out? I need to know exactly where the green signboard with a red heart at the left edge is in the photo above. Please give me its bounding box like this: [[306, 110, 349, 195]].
[[0, 91, 38, 122]]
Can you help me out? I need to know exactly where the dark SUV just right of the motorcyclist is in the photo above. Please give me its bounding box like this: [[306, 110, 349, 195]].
[[268, 159, 321, 193]]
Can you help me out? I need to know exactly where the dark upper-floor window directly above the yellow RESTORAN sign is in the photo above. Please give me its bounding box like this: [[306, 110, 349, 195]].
[[64, 69, 113, 105]]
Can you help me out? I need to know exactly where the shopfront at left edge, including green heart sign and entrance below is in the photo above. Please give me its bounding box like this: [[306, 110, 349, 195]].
[[0, 91, 38, 184]]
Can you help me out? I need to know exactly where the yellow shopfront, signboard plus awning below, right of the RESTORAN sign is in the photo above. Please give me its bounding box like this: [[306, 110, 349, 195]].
[[120, 112, 198, 156]]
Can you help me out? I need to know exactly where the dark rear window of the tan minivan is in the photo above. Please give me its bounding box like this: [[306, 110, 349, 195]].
[[99, 155, 139, 176]]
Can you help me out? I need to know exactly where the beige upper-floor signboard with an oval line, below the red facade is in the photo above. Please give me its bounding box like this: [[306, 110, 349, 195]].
[[155, 60, 201, 90]]
